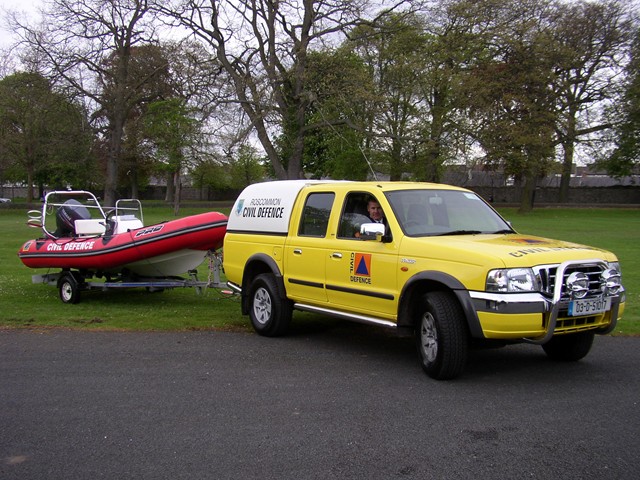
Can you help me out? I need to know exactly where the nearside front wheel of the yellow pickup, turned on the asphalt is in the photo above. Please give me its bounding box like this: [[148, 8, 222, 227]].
[[416, 292, 469, 380]]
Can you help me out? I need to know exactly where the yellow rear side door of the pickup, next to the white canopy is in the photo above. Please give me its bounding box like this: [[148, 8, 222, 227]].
[[284, 192, 335, 304]]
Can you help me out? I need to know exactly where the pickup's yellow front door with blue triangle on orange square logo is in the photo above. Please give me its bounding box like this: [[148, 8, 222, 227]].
[[326, 192, 398, 320]]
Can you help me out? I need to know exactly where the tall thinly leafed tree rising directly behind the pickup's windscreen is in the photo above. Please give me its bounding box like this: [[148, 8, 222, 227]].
[[415, 0, 501, 182]]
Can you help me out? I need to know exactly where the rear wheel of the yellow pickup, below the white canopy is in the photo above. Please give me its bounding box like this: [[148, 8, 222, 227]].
[[249, 273, 293, 337]]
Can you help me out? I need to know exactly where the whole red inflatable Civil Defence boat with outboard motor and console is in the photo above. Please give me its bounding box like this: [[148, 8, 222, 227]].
[[18, 191, 227, 278]]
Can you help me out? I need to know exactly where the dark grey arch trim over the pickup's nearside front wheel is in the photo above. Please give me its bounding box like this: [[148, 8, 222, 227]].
[[398, 270, 484, 338]]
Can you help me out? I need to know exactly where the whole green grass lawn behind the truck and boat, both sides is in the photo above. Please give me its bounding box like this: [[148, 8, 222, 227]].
[[0, 205, 640, 335]]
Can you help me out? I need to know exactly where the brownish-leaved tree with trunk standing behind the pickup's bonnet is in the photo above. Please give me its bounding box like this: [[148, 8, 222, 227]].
[[465, 0, 556, 211]]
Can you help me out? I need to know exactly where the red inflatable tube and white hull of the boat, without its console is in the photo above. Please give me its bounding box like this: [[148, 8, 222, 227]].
[[18, 212, 227, 277]]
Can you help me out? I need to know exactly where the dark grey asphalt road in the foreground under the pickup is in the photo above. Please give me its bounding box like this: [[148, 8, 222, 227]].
[[0, 322, 640, 480]]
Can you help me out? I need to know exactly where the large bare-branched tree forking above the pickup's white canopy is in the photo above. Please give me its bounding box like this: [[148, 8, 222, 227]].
[[162, 0, 403, 179]]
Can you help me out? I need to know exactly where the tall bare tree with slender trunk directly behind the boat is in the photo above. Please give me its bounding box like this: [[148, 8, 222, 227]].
[[13, 0, 157, 205]]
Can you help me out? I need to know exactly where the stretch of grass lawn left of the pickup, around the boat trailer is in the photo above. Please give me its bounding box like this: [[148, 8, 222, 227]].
[[0, 206, 249, 330]]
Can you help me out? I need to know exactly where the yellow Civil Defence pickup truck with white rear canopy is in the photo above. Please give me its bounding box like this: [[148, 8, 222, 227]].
[[223, 180, 625, 379]]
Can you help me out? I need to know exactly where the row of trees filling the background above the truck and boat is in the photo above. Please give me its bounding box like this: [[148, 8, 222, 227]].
[[0, 0, 640, 209]]
